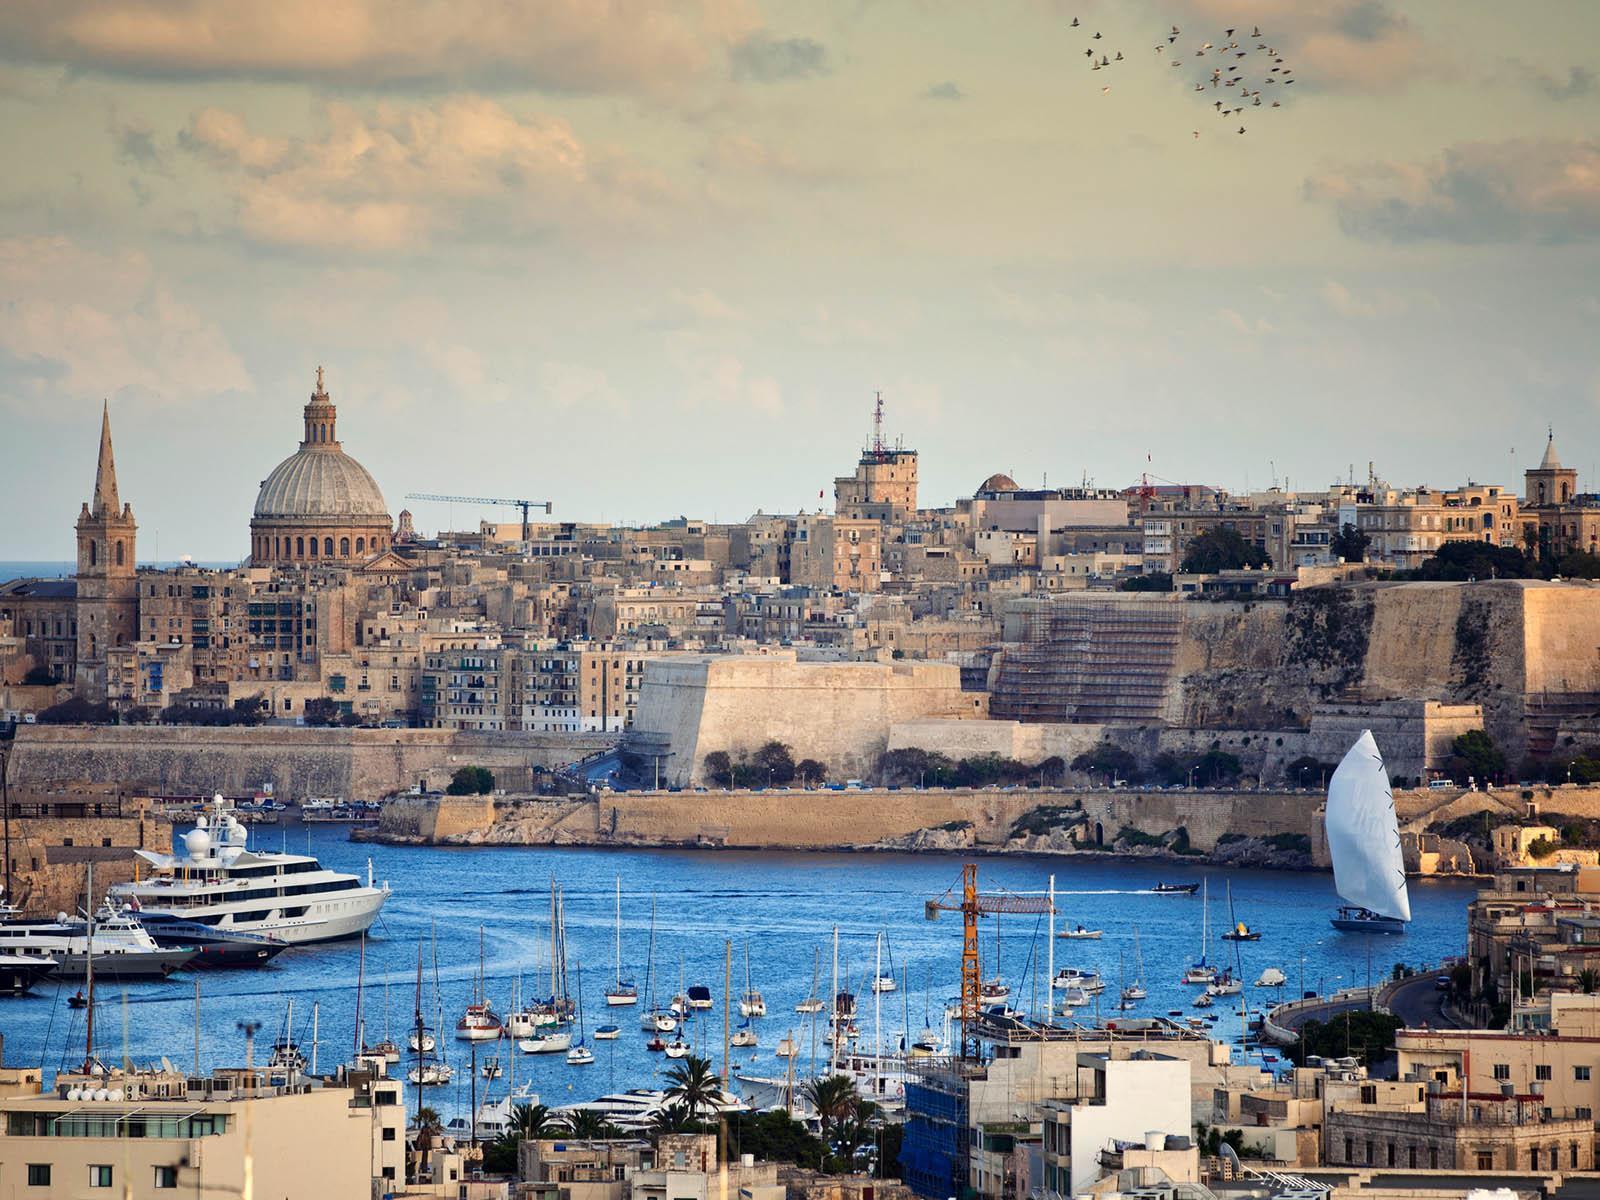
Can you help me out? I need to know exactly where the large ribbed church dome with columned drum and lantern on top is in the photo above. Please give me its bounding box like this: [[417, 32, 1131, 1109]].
[[250, 366, 394, 566]]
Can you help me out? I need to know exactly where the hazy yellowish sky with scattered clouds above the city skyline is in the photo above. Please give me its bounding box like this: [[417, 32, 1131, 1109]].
[[0, 0, 1600, 560]]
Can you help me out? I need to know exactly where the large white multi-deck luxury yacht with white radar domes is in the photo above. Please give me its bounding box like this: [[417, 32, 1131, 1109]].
[[110, 795, 390, 944]]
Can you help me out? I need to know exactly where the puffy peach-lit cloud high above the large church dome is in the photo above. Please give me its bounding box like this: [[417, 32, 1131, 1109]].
[[179, 96, 667, 253]]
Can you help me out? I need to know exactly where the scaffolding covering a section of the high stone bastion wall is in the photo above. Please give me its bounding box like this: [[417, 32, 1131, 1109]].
[[989, 594, 1182, 725]]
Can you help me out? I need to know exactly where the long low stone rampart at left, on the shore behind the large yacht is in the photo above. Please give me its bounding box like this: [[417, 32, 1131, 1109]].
[[8, 725, 614, 800]]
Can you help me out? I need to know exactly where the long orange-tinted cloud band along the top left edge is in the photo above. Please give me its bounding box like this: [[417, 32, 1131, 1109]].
[[0, 0, 758, 96]]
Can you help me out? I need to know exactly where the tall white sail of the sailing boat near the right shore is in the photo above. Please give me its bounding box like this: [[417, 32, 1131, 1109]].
[[1326, 731, 1411, 922]]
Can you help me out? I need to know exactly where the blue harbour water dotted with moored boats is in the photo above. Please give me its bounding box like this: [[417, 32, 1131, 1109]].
[[0, 826, 1472, 1114]]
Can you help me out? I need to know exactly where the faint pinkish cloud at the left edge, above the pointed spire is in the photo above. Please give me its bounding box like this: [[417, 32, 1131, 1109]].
[[0, 235, 254, 403]]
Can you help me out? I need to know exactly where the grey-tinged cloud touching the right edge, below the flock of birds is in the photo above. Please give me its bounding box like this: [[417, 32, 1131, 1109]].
[[1304, 138, 1600, 243]]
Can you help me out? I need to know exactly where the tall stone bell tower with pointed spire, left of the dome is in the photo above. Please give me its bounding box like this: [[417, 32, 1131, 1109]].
[[77, 408, 139, 704]]
